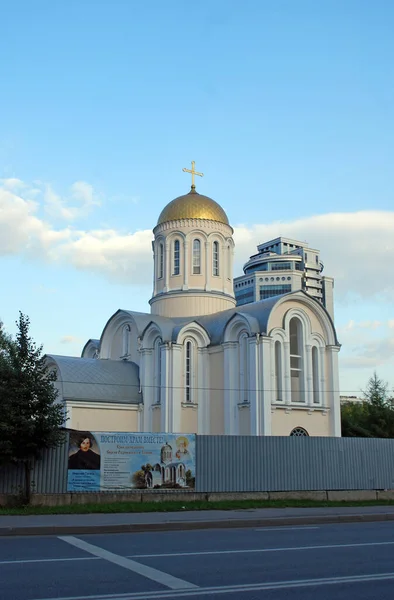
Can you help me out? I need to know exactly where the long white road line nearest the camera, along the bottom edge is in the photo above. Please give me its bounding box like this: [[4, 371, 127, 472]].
[[36, 573, 394, 600]]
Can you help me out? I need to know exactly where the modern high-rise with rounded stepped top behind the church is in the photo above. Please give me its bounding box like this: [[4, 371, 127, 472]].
[[234, 237, 334, 318]]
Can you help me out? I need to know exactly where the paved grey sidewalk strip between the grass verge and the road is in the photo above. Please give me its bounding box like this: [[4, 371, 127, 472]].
[[0, 506, 394, 536]]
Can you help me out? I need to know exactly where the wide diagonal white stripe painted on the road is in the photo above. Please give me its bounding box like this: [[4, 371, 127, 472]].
[[59, 535, 197, 590]]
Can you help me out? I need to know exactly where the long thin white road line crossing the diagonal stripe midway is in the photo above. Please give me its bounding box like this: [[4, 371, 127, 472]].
[[0, 538, 394, 567]]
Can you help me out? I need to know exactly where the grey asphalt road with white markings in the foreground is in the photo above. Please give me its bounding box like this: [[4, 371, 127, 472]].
[[0, 521, 394, 600]]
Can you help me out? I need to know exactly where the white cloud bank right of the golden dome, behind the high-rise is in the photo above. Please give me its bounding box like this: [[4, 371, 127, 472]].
[[234, 210, 394, 299]]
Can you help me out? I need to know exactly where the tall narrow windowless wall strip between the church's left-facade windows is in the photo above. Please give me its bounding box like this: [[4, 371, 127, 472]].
[[209, 351, 224, 435]]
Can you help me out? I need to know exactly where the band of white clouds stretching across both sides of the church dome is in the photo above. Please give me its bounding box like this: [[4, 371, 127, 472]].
[[0, 180, 394, 300]]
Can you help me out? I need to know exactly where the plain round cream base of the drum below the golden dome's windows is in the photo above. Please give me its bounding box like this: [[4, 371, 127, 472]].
[[152, 291, 235, 317]]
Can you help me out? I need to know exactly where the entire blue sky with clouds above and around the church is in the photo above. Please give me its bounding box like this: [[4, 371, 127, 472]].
[[0, 0, 394, 395]]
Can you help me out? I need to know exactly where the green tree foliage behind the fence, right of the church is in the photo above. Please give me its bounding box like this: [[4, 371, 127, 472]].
[[341, 373, 394, 438]]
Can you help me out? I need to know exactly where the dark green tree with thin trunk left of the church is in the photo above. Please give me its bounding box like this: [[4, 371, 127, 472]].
[[0, 313, 65, 503]]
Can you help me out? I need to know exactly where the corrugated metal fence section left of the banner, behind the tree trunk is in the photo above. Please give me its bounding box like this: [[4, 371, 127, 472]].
[[0, 434, 68, 494]]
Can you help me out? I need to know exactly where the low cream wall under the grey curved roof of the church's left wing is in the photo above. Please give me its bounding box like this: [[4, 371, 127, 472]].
[[68, 406, 139, 431]]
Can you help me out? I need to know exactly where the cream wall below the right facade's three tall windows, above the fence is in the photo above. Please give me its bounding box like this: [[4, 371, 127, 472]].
[[271, 409, 332, 436]]
